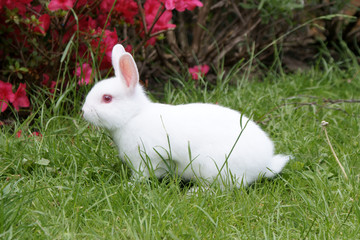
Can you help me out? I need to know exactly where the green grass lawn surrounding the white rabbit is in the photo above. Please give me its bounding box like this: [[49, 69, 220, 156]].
[[0, 62, 360, 239]]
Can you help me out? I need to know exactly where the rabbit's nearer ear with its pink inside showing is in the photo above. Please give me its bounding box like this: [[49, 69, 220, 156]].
[[118, 52, 139, 88]]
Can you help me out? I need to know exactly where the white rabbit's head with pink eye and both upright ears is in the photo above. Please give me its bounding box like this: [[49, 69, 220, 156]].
[[82, 44, 149, 131]]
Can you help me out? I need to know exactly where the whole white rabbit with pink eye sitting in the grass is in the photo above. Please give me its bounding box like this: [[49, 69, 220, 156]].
[[82, 44, 290, 187]]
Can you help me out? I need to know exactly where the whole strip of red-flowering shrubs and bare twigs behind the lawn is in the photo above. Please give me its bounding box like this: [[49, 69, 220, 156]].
[[0, 0, 359, 120]]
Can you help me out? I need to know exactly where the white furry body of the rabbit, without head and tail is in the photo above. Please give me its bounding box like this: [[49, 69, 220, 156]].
[[115, 103, 273, 185]]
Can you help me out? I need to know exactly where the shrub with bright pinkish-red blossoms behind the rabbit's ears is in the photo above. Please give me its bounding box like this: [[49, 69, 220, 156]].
[[0, 0, 203, 112]]
